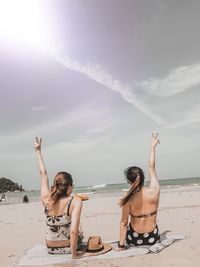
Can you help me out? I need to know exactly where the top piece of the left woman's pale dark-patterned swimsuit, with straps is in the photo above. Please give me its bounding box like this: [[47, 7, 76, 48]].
[[45, 197, 73, 241]]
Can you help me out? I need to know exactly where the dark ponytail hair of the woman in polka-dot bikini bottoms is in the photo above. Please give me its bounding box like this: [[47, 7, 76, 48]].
[[120, 166, 145, 207]]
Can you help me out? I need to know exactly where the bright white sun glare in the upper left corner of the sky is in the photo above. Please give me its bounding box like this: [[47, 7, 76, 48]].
[[0, 0, 51, 49]]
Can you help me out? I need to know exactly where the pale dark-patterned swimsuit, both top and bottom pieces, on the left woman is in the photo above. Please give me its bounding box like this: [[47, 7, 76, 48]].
[[45, 197, 80, 254]]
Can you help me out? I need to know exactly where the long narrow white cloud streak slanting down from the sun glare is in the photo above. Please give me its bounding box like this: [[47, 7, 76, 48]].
[[38, 46, 165, 125]]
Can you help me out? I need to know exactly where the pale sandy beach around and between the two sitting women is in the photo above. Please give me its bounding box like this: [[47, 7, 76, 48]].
[[0, 186, 200, 267]]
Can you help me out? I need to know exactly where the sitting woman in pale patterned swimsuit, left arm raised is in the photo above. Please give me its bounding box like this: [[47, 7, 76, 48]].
[[34, 138, 82, 258]]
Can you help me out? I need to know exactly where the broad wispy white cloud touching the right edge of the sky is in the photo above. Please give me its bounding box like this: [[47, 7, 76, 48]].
[[137, 64, 200, 97]]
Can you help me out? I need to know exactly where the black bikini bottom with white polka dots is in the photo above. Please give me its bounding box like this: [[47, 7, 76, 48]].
[[126, 224, 160, 246]]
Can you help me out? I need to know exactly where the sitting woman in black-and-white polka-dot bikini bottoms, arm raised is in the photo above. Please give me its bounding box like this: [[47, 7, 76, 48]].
[[118, 133, 160, 249]]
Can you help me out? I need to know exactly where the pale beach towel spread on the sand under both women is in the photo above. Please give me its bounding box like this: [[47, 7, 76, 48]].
[[15, 235, 185, 267]]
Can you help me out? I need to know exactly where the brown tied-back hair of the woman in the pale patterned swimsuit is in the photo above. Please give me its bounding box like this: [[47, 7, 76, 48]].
[[50, 172, 73, 205]]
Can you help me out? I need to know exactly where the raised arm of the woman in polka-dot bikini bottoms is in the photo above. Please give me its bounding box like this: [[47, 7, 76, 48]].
[[149, 133, 160, 192]]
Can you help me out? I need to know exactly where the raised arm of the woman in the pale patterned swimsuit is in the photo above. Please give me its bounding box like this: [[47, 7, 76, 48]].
[[34, 137, 49, 205]]
